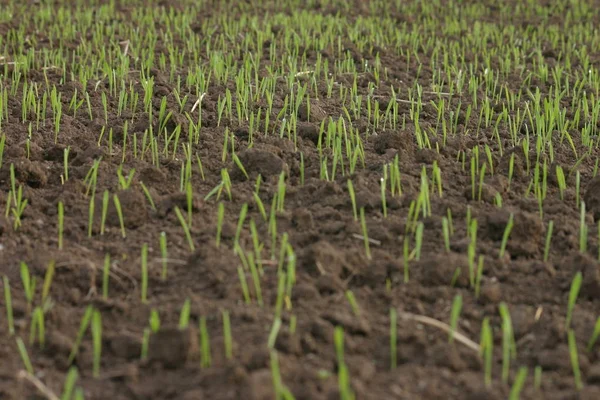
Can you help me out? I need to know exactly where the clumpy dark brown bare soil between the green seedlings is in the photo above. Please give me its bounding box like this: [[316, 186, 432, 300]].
[[0, 1, 600, 400]]
